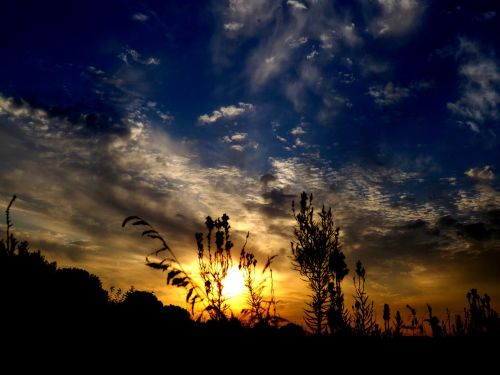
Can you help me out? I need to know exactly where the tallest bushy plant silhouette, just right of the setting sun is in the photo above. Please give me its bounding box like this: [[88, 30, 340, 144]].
[[291, 192, 348, 335]]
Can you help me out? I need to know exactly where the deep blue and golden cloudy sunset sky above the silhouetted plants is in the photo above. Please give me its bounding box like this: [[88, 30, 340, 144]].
[[0, 0, 500, 323]]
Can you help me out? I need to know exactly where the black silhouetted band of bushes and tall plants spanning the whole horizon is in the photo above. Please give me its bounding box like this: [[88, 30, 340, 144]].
[[0, 193, 500, 366]]
